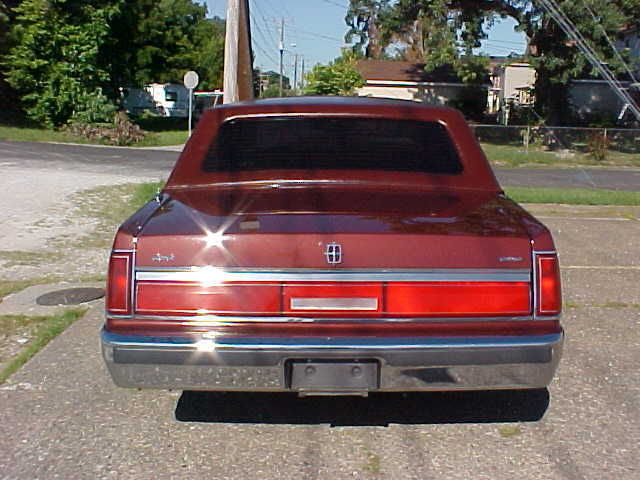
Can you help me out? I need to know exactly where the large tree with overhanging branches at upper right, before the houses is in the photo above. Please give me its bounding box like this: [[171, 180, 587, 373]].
[[347, 0, 640, 123]]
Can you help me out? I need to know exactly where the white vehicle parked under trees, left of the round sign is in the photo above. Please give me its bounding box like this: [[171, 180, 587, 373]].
[[122, 83, 193, 117]]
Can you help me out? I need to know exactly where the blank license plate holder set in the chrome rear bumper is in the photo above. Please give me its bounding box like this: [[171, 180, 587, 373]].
[[290, 360, 380, 393]]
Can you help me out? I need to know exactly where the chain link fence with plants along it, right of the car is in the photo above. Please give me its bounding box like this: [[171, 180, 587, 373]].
[[473, 125, 640, 154]]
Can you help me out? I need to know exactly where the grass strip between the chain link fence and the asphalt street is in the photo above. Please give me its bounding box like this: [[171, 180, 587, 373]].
[[482, 143, 640, 167]]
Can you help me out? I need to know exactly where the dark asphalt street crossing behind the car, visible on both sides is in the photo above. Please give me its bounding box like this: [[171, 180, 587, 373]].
[[0, 142, 640, 191]]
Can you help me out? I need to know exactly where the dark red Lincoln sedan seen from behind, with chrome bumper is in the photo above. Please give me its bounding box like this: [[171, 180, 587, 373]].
[[101, 97, 563, 395]]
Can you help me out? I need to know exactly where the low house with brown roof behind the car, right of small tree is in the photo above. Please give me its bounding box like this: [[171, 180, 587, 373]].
[[356, 60, 489, 106]]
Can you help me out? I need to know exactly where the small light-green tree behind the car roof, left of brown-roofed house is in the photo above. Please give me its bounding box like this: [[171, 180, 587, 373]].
[[304, 51, 365, 95]]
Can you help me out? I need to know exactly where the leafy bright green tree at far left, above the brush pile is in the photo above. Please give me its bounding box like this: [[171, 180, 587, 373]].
[[5, 0, 118, 126]]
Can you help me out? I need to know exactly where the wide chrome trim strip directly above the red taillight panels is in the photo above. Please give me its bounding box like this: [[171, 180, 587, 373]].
[[136, 267, 531, 283]]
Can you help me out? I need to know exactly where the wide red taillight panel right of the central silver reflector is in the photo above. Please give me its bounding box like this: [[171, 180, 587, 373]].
[[386, 282, 531, 317]]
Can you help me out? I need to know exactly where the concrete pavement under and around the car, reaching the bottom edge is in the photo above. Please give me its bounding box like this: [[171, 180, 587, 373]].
[[0, 207, 640, 480]]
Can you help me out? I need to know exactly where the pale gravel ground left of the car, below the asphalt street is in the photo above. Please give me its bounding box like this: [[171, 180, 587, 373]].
[[0, 156, 164, 280]]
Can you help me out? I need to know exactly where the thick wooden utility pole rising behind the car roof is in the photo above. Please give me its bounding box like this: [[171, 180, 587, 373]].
[[223, 0, 253, 103]]
